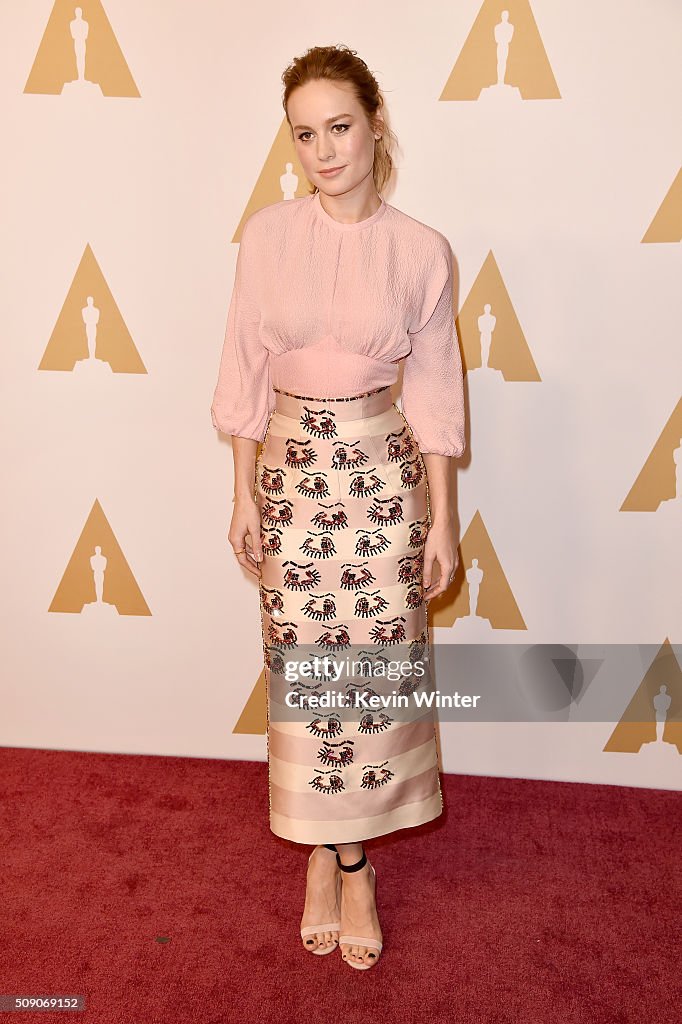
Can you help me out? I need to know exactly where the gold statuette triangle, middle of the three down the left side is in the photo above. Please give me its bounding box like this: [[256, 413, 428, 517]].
[[38, 245, 146, 374]]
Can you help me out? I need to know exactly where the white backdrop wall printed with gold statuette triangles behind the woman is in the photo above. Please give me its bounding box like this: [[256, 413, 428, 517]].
[[0, 0, 682, 788]]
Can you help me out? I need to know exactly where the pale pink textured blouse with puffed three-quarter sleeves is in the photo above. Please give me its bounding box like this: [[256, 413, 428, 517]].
[[211, 193, 465, 456]]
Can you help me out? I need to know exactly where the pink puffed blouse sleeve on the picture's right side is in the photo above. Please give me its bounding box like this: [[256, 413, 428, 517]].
[[402, 234, 466, 457]]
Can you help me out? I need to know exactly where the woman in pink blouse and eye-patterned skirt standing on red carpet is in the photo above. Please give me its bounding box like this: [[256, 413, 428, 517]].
[[211, 46, 465, 970]]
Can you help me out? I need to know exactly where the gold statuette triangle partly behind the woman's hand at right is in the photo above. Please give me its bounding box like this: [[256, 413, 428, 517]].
[[429, 512, 526, 630]]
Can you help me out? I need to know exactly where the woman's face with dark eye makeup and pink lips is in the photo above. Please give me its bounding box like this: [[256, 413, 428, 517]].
[[287, 79, 380, 196]]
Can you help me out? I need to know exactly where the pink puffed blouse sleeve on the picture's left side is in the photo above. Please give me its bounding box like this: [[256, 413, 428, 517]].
[[211, 214, 274, 441]]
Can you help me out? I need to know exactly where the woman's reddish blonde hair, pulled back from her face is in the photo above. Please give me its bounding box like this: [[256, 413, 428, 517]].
[[282, 45, 397, 196]]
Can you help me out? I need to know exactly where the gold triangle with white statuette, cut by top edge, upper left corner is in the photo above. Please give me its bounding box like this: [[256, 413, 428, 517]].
[[24, 0, 139, 97]]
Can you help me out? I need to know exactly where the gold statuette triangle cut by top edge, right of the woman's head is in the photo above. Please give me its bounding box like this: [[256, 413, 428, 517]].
[[438, 0, 561, 99]]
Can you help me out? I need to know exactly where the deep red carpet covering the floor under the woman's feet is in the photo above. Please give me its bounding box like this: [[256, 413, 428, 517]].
[[0, 748, 681, 1024]]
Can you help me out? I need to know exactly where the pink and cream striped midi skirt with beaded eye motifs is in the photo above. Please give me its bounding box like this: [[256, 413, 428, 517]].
[[254, 387, 442, 844]]
